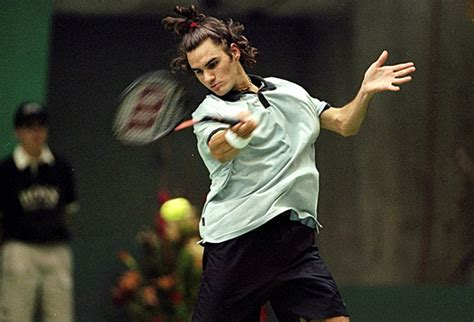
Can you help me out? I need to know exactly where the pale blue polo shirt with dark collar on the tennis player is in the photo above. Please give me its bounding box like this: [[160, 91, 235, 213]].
[[193, 77, 328, 243]]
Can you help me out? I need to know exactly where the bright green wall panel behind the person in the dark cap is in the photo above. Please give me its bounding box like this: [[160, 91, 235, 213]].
[[0, 0, 53, 157]]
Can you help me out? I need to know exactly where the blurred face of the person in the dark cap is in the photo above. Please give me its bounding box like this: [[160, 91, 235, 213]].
[[15, 125, 48, 158]]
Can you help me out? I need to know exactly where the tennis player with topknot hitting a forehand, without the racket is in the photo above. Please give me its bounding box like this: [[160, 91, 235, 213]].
[[163, 6, 415, 322]]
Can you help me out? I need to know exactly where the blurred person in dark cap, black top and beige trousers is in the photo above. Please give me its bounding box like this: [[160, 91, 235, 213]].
[[0, 102, 78, 322]]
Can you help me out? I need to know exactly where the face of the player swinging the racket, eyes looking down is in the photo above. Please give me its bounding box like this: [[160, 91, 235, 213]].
[[186, 38, 247, 96]]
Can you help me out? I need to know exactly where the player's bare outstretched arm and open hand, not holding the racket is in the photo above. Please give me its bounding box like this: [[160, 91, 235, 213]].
[[321, 50, 415, 136]]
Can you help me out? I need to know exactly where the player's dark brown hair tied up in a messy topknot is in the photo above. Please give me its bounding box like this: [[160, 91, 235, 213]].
[[161, 5, 258, 71]]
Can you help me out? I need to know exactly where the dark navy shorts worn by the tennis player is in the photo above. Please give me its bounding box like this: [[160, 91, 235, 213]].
[[192, 214, 348, 322]]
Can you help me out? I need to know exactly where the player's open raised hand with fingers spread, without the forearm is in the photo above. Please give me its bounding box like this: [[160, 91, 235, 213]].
[[362, 50, 416, 94]]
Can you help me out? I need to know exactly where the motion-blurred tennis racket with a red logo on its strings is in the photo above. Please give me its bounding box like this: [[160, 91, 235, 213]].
[[113, 70, 240, 145]]
